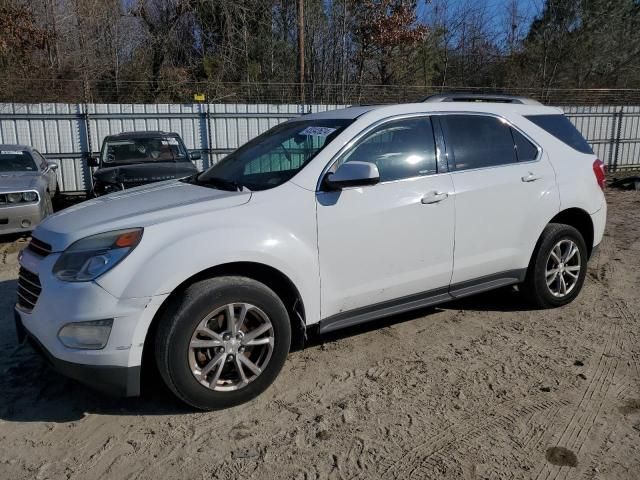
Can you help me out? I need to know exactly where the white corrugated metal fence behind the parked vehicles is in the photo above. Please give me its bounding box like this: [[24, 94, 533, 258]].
[[0, 103, 640, 191]]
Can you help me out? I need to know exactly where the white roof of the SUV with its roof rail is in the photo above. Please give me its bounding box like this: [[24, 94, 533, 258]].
[[294, 101, 562, 121]]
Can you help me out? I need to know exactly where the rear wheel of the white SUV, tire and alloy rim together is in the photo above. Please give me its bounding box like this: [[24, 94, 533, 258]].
[[523, 223, 588, 308]]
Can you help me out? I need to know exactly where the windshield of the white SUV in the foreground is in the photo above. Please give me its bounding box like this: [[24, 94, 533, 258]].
[[188, 119, 353, 190]]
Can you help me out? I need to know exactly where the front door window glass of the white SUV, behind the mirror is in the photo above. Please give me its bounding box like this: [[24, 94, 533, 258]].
[[339, 117, 437, 182]]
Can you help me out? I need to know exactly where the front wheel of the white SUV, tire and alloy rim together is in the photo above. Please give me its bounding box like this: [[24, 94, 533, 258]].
[[155, 276, 291, 410]]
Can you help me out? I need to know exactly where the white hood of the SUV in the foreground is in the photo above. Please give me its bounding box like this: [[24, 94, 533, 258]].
[[33, 180, 251, 252]]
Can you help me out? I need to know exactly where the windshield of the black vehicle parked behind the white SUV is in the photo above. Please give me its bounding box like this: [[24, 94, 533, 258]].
[[102, 137, 188, 164]]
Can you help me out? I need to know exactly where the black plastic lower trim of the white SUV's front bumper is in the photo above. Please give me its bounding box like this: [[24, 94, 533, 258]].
[[15, 312, 141, 397]]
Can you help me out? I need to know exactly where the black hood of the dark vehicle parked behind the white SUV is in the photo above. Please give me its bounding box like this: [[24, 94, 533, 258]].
[[93, 162, 197, 187]]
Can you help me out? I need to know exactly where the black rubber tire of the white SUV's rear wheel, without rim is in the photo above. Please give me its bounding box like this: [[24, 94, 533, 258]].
[[522, 223, 588, 308]]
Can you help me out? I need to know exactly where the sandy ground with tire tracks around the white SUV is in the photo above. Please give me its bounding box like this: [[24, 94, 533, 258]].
[[0, 191, 640, 480]]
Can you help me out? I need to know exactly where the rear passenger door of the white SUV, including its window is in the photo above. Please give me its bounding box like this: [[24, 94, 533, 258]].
[[438, 114, 559, 295]]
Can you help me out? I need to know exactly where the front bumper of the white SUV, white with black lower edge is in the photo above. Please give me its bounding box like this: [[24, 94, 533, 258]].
[[15, 249, 167, 396]]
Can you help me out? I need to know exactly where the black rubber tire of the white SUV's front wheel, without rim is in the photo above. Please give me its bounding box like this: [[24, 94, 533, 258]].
[[155, 276, 291, 410]]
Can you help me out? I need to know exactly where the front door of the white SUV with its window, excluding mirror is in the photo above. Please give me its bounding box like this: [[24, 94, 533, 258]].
[[317, 116, 454, 330]]
